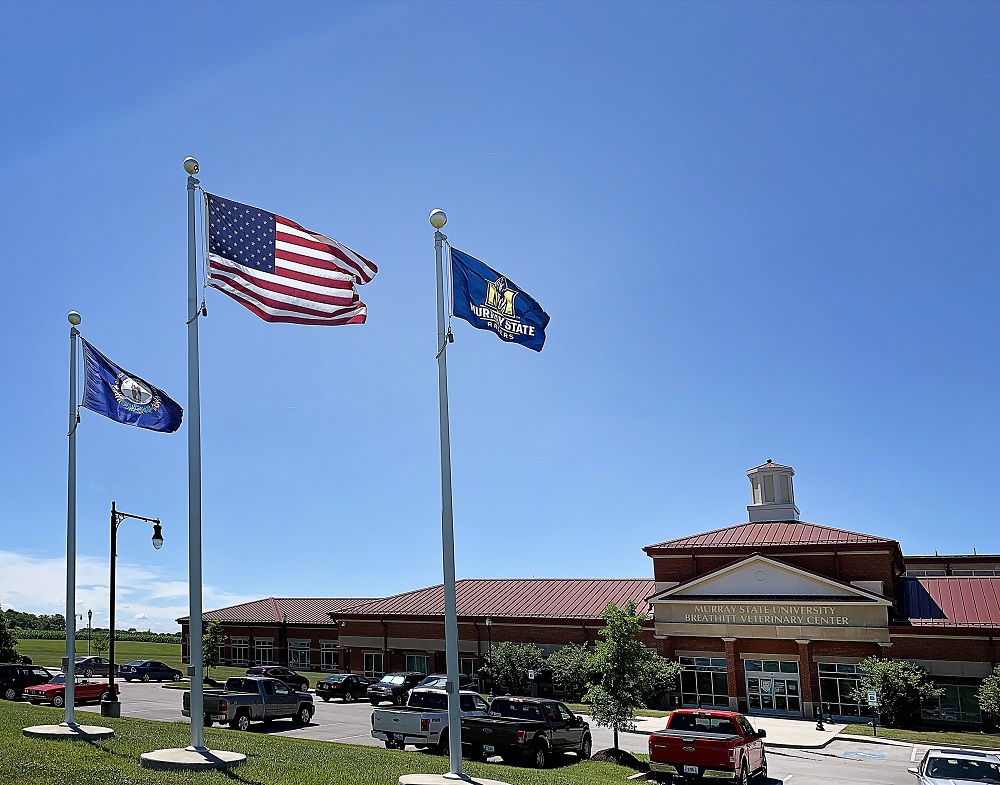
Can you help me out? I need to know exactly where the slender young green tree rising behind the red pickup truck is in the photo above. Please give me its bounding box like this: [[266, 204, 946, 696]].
[[583, 601, 656, 751]]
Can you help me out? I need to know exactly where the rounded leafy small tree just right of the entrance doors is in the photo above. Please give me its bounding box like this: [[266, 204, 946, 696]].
[[852, 657, 944, 728]]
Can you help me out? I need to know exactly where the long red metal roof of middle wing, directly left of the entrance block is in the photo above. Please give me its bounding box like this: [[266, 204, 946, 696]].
[[345, 578, 654, 619]]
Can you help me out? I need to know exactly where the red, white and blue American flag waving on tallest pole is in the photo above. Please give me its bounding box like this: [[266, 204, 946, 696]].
[[205, 194, 378, 324]]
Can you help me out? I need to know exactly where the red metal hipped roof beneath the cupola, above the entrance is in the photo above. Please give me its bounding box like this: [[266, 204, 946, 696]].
[[643, 521, 895, 552]]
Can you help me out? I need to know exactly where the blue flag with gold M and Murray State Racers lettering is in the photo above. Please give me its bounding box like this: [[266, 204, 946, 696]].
[[451, 248, 549, 352]]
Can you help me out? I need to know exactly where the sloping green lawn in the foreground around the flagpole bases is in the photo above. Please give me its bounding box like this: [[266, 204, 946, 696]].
[[0, 700, 634, 785]]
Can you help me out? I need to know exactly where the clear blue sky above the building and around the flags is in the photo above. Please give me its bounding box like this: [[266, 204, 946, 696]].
[[0, 2, 1000, 630]]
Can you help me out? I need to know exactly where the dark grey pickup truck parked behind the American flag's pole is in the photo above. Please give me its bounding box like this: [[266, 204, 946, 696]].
[[181, 676, 315, 730]]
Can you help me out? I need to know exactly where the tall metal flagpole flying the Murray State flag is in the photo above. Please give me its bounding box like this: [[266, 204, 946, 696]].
[[429, 210, 462, 778]]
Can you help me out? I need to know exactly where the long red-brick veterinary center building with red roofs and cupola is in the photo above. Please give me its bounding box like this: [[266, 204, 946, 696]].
[[178, 460, 1000, 724]]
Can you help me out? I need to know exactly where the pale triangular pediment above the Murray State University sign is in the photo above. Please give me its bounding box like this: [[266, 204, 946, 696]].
[[649, 554, 891, 605]]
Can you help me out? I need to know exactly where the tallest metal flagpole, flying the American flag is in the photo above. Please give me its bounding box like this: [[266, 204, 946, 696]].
[[184, 158, 206, 751]]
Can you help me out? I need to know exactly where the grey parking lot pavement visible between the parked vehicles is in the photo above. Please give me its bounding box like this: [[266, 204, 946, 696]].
[[19, 683, 926, 785]]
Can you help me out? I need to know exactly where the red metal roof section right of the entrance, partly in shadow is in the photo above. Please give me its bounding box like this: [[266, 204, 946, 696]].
[[903, 576, 1000, 627]]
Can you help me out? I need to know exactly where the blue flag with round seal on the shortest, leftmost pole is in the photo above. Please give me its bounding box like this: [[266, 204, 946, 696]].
[[81, 338, 184, 433]]
